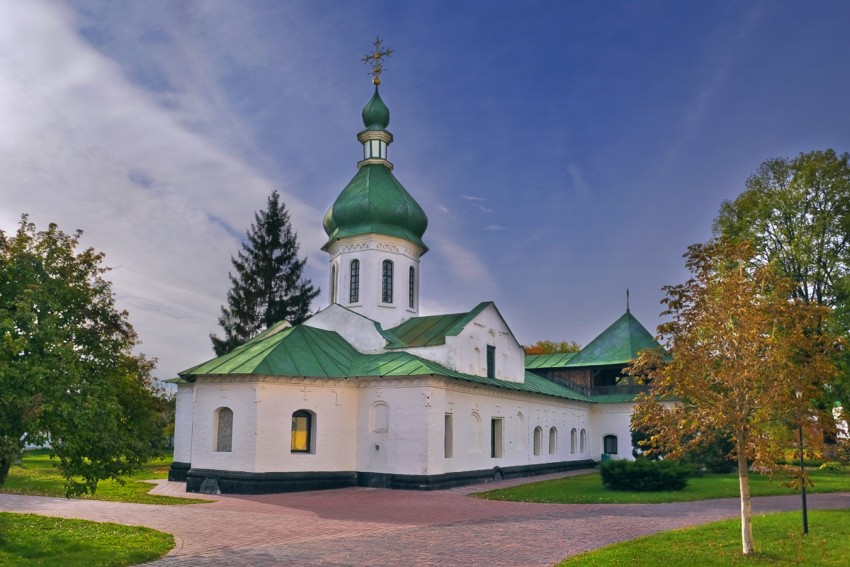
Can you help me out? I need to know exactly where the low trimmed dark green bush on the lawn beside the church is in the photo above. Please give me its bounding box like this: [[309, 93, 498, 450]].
[[599, 459, 690, 492]]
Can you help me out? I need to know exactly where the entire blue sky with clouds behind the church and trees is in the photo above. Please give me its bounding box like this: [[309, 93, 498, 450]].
[[0, 0, 850, 378]]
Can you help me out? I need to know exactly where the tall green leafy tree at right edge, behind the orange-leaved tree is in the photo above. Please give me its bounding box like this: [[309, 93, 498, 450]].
[[714, 149, 850, 418]]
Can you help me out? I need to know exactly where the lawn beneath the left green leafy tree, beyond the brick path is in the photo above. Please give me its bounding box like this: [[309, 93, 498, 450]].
[[0, 449, 209, 504]]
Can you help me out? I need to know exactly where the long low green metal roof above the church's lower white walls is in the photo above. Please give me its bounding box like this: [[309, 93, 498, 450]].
[[180, 320, 590, 401]]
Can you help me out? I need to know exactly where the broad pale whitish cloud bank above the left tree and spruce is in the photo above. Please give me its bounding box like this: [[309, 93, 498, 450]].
[[0, 2, 324, 375]]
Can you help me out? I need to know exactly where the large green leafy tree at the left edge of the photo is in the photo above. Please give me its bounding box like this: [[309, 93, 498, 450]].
[[0, 216, 162, 496]]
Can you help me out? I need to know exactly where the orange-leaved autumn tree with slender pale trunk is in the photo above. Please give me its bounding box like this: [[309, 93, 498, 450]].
[[629, 240, 841, 554]]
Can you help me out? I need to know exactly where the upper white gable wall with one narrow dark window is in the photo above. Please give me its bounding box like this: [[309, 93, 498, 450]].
[[405, 305, 525, 382]]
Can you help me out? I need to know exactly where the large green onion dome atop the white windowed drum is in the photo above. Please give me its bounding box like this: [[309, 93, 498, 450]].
[[322, 163, 428, 254]]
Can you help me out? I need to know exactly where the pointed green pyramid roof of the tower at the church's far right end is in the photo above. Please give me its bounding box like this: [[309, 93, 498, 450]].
[[564, 311, 661, 368]]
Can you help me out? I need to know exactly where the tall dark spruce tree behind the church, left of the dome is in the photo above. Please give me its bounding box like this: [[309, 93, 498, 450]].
[[210, 191, 319, 356]]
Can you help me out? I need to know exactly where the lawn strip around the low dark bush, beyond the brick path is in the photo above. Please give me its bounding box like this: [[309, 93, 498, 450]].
[[475, 469, 850, 504]]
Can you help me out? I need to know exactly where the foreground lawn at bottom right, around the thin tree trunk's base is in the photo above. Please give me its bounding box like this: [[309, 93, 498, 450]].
[[558, 510, 850, 567]]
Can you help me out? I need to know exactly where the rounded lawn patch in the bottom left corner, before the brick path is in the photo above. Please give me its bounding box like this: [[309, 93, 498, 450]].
[[0, 512, 174, 567]]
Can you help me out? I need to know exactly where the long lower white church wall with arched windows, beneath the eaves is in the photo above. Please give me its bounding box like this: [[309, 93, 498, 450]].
[[177, 376, 604, 475]]
